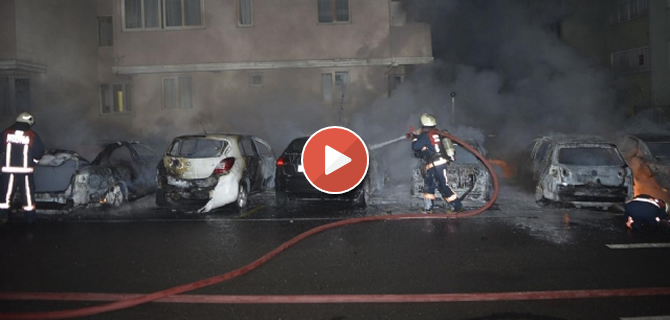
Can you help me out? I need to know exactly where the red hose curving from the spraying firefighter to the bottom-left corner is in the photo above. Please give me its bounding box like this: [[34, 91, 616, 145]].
[[0, 132, 499, 319]]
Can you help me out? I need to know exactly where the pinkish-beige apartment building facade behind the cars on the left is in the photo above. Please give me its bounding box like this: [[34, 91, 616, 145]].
[[0, 0, 433, 149]]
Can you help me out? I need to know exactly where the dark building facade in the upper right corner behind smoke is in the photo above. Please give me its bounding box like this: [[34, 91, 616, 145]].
[[562, 0, 670, 114]]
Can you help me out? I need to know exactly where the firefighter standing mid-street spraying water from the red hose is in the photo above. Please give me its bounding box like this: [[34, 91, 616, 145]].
[[412, 113, 463, 213]]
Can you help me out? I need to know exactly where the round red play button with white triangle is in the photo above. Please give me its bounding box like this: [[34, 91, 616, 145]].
[[302, 127, 369, 194]]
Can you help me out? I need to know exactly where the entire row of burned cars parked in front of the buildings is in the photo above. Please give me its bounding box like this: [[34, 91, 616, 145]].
[[35, 133, 670, 212]]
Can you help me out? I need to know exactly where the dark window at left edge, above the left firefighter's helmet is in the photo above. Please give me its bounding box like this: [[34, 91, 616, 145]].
[[0, 77, 31, 115]]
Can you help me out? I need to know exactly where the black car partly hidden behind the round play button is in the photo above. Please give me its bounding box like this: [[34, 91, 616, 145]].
[[275, 137, 378, 206]]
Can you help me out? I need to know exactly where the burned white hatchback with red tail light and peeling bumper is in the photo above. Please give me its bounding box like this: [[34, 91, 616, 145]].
[[156, 133, 276, 212]]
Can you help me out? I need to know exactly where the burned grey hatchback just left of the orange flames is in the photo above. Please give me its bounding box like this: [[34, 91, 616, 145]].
[[524, 135, 633, 209]]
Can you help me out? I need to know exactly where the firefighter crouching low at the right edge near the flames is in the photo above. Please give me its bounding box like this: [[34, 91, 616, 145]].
[[624, 194, 670, 231]]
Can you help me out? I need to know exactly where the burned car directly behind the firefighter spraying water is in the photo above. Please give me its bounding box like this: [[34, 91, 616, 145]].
[[412, 140, 493, 203]]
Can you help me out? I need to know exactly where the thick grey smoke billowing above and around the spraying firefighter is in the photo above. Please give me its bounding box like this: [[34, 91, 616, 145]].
[[352, 0, 626, 186]]
